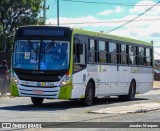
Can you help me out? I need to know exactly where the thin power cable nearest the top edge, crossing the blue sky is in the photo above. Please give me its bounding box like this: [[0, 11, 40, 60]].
[[61, 0, 159, 6]]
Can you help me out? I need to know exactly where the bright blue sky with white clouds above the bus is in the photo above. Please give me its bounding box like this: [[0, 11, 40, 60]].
[[40, 0, 160, 59]]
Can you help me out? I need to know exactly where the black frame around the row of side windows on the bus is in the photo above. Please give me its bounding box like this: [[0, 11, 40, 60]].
[[73, 34, 153, 68]]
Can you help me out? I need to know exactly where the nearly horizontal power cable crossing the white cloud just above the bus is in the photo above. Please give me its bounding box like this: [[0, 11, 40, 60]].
[[46, 18, 160, 25]]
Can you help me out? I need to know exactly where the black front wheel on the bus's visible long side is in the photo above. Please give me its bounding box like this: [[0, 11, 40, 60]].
[[81, 82, 94, 106]]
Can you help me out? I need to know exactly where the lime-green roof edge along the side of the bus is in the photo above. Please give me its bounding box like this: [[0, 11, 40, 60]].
[[73, 28, 153, 46]]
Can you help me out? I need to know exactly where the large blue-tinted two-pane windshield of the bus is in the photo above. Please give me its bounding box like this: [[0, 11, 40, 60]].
[[13, 40, 69, 70]]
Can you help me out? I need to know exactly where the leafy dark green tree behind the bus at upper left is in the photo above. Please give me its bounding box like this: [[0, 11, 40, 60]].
[[0, 0, 43, 50]]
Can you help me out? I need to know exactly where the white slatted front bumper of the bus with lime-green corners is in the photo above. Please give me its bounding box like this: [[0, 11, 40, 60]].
[[11, 83, 72, 99]]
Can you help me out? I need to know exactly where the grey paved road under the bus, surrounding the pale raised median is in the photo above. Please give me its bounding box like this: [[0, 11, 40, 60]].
[[0, 90, 160, 130]]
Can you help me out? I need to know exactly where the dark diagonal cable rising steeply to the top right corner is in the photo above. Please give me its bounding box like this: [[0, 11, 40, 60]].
[[107, 1, 160, 33]]
